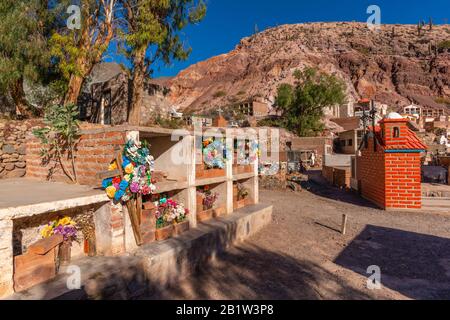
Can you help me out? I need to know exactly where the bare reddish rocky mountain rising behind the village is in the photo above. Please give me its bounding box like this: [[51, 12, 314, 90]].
[[162, 22, 450, 112]]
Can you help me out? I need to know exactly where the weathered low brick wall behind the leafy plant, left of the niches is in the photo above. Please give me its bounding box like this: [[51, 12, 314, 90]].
[[26, 130, 126, 186]]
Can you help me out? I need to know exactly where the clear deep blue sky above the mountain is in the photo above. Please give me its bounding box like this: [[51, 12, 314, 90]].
[[104, 0, 450, 78]]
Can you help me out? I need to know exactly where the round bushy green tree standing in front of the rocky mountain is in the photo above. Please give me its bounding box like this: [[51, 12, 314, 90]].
[[275, 68, 345, 136]]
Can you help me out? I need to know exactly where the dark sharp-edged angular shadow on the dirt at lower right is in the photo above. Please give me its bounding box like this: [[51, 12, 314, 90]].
[[334, 225, 450, 299]]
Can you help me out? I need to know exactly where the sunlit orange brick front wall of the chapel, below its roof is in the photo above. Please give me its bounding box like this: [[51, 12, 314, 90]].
[[385, 153, 422, 209]]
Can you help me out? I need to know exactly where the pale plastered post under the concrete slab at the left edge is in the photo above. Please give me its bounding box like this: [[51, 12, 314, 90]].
[[0, 220, 14, 298]]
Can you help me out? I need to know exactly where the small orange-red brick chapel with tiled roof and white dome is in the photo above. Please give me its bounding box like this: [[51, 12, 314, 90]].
[[356, 113, 427, 210]]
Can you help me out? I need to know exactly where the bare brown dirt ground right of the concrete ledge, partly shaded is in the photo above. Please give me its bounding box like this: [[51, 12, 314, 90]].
[[147, 174, 450, 299]]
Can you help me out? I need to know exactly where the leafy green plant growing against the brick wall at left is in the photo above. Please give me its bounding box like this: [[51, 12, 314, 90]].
[[33, 104, 79, 182]]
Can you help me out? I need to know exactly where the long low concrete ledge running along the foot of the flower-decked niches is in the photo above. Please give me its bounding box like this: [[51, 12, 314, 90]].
[[8, 204, 272, 300]]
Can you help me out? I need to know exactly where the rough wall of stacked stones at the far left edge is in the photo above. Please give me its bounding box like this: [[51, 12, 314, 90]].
[[0, 120, 39, 179]]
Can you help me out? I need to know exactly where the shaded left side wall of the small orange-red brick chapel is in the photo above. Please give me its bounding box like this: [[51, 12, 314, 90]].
[[356, 139, 386, 208]]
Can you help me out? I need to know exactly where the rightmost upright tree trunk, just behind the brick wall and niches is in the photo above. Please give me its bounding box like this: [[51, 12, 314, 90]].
[[128, 49, 146, 126]]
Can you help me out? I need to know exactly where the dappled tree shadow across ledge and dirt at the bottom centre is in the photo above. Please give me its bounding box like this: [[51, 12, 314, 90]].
[[53, 245, 370, 300]]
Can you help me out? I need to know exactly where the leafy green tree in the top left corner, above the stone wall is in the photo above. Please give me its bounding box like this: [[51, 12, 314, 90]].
[[0, 0, 50, 116]]
